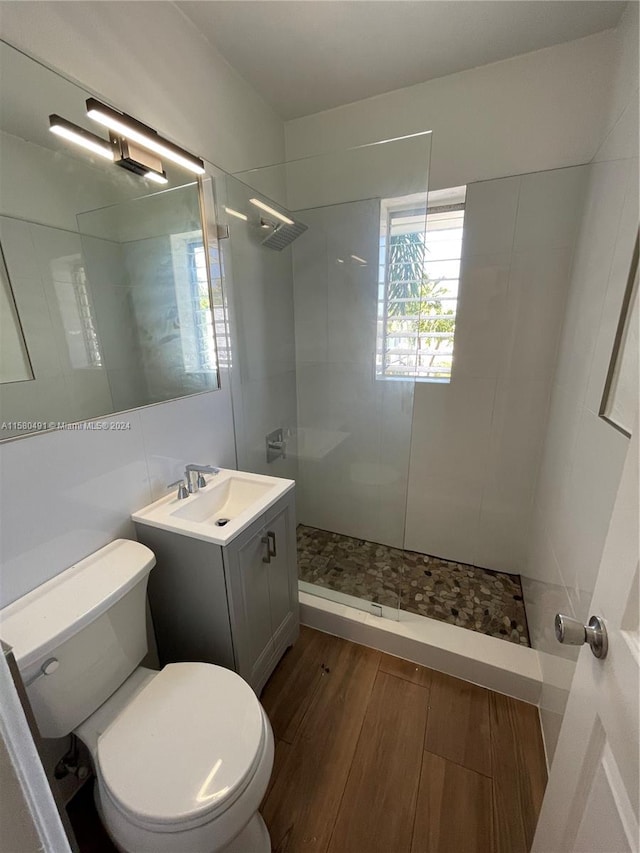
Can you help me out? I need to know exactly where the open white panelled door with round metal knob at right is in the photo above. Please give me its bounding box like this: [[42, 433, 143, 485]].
[[532, 429, 640, 853]]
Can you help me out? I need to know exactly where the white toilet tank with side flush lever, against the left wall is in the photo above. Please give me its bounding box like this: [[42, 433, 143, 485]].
[[0, 539, 155, 738]]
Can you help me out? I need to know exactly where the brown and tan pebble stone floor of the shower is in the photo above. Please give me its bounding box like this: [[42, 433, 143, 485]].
[[298, 524, 529, 646]]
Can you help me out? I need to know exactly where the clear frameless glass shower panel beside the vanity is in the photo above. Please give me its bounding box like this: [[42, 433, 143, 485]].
[[222, 133, 431, 618]]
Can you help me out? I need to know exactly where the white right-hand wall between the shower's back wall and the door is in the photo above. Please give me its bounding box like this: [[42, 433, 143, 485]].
[[523, 4, 638, 758]]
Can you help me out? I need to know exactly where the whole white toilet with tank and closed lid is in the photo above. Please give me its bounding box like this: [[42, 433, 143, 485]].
[[0, 539, 273, 853]]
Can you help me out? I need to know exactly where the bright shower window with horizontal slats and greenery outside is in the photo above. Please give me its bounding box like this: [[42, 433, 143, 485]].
[[376, 187, 466, 382]]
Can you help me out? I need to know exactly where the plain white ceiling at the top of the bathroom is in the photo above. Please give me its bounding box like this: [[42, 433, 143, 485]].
[[176, 0, 626, 119]]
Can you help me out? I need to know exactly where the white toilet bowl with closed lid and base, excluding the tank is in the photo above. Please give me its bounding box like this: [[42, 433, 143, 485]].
[[75, 663, 274, 853]]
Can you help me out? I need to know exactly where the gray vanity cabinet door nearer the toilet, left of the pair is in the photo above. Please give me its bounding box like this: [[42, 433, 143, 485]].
[[225, 527, 273, 685]]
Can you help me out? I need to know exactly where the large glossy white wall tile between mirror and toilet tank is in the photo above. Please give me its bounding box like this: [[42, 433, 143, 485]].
[[0, 412, 151, 604]]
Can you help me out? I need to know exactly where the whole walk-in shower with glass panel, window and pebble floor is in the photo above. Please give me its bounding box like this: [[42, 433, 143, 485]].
[[215, 133, 584, 646]]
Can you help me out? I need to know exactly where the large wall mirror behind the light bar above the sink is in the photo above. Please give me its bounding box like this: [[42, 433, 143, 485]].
[[0, 43, 220, 440]]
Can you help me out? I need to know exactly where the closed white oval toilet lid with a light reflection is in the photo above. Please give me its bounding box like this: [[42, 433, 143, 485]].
[[97, 663, 264, 831]]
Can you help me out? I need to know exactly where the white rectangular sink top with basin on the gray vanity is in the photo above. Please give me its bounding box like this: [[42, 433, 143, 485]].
[[131, 469, 295, 545]]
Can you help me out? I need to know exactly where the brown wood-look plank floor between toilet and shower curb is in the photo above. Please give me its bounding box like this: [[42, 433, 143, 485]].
[[261, 628, 547, 853]]
